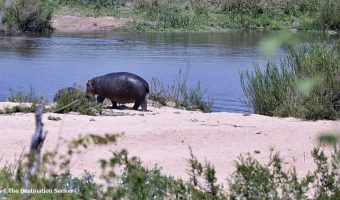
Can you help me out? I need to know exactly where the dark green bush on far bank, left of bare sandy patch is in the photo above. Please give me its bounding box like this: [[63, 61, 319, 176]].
[[0, 0, 52, 32]]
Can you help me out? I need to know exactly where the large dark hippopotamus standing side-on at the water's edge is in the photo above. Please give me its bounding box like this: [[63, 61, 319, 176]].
[[86, 72, 149, 111]]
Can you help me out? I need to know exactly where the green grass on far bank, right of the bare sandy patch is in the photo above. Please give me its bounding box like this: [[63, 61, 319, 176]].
[[131, 0, 340, 30]]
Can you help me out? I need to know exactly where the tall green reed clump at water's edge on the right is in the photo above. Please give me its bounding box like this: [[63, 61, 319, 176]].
[[241, 44, 340, 120]]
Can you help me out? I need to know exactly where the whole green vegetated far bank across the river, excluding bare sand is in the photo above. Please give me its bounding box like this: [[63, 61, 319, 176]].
[[0, 0, 340, 32]]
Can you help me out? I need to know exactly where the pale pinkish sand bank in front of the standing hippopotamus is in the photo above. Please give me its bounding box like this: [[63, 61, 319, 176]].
[[0, 102, 340, 182]]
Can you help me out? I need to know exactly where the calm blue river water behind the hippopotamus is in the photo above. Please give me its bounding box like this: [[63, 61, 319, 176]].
[[0, 31, 338, 112]]
